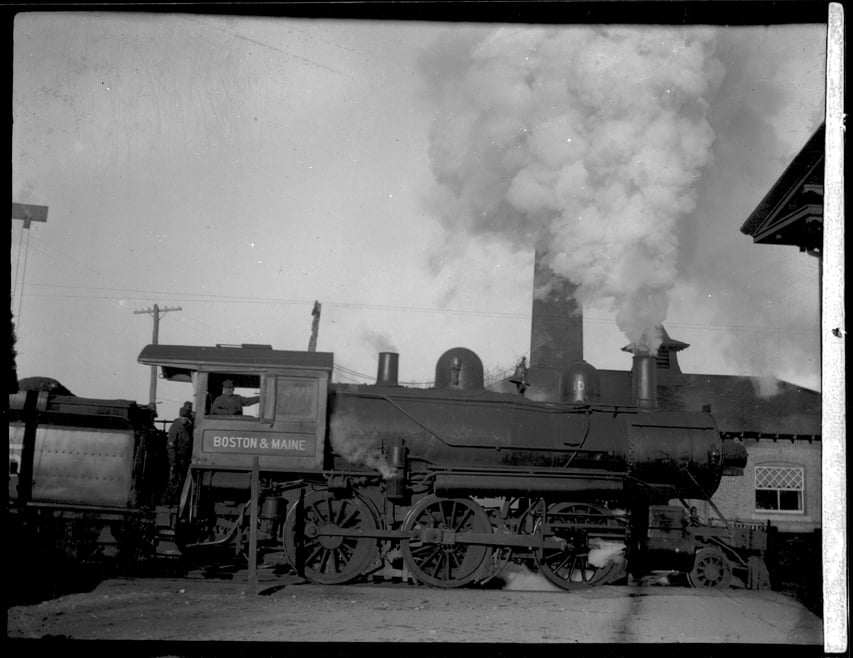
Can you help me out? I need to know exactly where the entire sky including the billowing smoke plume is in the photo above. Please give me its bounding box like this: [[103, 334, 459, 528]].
[[10, 12, 826, 418]]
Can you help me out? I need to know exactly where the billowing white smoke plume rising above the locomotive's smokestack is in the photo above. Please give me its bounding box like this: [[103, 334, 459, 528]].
[[425, 27, 722, 352]]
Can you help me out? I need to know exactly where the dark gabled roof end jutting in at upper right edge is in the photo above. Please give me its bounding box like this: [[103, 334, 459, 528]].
[[740, 124, 826, 251]]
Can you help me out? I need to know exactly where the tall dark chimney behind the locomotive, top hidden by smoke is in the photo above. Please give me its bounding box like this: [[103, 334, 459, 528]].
[[530, 250, 583, 369]]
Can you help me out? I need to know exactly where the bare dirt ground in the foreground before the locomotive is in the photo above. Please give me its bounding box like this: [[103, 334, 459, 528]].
[[7, 573, 822, 644]]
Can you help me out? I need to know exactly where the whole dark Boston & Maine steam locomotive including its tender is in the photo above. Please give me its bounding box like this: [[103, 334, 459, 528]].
[[10, 345, 767, 590]]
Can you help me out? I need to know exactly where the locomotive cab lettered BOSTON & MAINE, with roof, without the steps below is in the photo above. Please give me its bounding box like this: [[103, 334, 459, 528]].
[[139, 345, 332, 471]]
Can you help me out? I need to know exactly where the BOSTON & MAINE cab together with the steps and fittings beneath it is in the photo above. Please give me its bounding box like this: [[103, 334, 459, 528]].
[[139, 345, 332, 553]]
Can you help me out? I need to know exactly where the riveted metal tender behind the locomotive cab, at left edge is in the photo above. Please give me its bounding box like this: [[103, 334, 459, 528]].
[[7, 390, 168, 565]]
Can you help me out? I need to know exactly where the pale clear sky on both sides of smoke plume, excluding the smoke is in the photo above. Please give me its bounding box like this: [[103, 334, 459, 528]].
[[11, 13, 826, 418]]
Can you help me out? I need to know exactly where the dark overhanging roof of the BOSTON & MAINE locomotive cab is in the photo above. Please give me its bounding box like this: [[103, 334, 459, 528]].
[[138, 345, 334, 379]]
